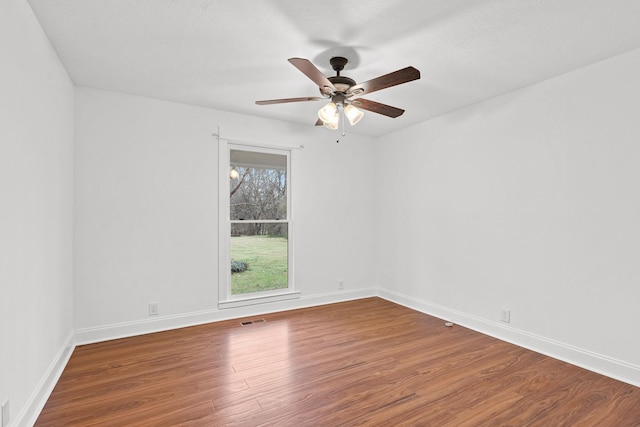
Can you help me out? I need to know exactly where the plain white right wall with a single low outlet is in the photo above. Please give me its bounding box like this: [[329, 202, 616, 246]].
[[376, 50, 640, 385]]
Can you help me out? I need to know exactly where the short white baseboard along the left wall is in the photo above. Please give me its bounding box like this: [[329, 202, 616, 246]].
[[16, 332, 75, 426]]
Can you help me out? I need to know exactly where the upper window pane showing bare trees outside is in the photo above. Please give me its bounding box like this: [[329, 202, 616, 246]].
[[229, 150, 287, 220]]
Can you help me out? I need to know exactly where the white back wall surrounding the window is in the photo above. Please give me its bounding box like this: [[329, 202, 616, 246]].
[[75, 88, 374, 341]]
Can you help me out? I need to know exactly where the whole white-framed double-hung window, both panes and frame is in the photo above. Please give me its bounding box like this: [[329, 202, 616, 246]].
[[220, 144, 297, 308]]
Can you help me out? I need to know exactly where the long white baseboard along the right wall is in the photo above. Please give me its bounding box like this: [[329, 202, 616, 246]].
[[377, 288, 640, 387]]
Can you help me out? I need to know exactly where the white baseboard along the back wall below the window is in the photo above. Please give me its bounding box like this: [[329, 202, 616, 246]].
[[75, 288, 376, 345]]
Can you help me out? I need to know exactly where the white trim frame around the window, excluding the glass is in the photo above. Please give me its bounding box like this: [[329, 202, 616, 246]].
[[218, 139, 300, 309]]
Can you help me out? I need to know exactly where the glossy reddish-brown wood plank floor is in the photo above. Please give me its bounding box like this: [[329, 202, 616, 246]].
[[36, 298, 640, 427]]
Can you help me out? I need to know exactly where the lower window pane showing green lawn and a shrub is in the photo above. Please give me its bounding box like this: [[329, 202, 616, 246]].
[[231, 223, 289, 295]]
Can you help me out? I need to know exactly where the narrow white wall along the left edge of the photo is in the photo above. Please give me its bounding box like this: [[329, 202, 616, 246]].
[[0, 0, 74, 425]]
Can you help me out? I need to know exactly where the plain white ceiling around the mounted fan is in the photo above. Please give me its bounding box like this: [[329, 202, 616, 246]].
[[28, 0, 640, 135]]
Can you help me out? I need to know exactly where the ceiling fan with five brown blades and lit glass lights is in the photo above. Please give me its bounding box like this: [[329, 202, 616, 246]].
[[256, 56, 420, 130]]
